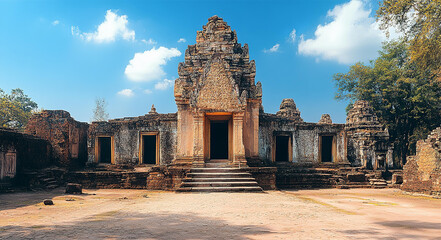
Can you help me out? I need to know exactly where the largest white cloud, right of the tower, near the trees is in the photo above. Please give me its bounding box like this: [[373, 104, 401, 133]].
[[298, 0, 397, 64]]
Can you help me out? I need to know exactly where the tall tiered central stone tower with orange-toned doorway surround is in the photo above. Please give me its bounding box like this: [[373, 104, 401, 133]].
[[174, 16, 262, 167]]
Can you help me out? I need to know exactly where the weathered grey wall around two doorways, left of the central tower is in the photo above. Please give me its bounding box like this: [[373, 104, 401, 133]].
[[88, 113, 177, 165]]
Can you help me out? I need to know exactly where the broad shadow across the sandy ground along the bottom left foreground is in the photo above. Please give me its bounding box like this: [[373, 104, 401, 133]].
[[0, 211, 271, 240]]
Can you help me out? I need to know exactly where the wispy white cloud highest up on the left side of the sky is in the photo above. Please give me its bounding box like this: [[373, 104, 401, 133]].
[[71, 10, 135, 43]]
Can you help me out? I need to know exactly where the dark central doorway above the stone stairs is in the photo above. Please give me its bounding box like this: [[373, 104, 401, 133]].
[[210, 121, 228, 159]]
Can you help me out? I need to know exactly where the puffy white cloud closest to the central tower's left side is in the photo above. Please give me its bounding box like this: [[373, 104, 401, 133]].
[[124, 47, 181, 82]]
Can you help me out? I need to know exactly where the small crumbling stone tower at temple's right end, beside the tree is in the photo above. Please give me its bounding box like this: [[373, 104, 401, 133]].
[[345, 101, 393, 169]]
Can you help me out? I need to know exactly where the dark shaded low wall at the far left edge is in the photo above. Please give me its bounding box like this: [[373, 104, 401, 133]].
[[0, 128, 52, 181]]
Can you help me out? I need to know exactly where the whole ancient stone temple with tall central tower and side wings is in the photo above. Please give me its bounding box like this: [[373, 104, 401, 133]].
[[20, 16, 392, 189]]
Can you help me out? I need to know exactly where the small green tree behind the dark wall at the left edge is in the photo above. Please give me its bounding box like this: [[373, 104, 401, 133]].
[[0, 88, 37, 129]]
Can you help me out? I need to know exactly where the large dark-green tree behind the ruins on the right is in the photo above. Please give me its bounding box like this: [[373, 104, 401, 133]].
[[334, 40, 441, 167]]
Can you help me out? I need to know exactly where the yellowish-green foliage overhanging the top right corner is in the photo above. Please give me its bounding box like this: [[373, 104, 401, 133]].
[[377, 0, 441, 73]]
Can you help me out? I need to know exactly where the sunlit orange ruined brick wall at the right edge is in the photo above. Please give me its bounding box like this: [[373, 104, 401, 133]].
[[401, 128, 441, 195]]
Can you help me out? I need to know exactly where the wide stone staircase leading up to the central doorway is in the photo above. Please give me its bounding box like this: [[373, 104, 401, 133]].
[[177, 167, 263, 192]]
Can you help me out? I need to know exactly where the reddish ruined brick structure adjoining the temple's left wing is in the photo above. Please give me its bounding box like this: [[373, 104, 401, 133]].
[[25, 110, 88, 168]]
